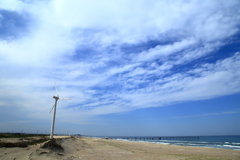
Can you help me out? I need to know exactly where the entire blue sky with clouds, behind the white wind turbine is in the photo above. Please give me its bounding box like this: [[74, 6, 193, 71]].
[[0, 0, 240, 136]]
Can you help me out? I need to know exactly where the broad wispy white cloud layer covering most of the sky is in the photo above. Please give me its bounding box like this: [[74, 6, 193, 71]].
[[0, 0, 240, 123]]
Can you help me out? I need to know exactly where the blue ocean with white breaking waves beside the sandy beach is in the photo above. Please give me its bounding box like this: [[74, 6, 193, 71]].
[[94, 136, 240, 150]]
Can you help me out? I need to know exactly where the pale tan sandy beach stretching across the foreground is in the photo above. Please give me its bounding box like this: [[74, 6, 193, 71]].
[[0, 137, 240, 160]]
